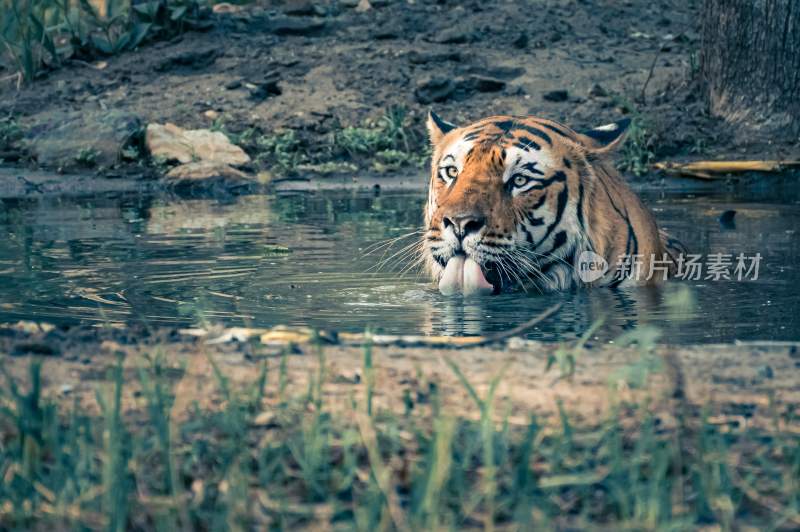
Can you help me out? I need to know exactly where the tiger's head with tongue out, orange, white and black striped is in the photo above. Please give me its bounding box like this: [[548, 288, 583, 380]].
[[423, 112, 629, 294]]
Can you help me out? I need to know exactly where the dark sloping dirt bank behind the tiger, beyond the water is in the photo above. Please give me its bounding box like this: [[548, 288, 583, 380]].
[[0, 0, 797, 180]]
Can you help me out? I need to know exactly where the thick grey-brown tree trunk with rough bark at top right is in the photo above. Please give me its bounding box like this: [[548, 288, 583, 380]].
[[701, 0, 800, 134]]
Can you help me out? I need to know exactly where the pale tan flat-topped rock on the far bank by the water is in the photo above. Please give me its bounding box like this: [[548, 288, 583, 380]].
[[145, 123, 250, 166]]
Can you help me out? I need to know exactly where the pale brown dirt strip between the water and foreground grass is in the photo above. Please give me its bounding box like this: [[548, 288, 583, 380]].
[[0, 324, 800, 432]]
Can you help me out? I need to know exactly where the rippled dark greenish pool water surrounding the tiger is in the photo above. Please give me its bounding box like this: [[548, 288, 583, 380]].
[[0, 183, 800, 344]]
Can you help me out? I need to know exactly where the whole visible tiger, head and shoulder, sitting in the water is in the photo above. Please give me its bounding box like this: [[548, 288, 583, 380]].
[[422, 111, 684, 295]]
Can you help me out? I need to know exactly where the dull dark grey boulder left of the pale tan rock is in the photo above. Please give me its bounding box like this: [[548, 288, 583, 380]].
[[25, 110, 142, 170]]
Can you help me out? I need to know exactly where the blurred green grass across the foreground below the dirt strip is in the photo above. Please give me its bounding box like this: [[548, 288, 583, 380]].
[[0, 344, 800, 530]]
